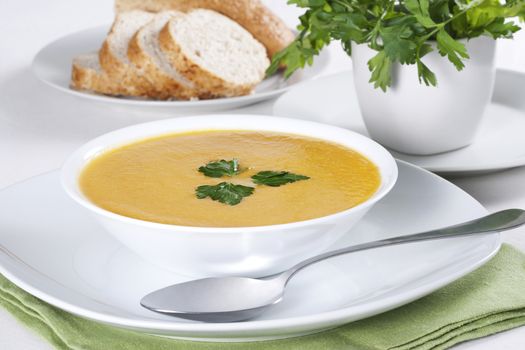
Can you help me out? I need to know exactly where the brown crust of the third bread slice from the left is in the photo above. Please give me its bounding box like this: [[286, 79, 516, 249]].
[[128, 22, 211, 100]]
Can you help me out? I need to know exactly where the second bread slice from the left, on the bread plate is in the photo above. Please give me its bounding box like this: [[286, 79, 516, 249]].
[[99, 11, 155, 96]]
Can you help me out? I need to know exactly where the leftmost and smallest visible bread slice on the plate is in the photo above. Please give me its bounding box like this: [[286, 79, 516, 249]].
[[71, 52, 124, 96]]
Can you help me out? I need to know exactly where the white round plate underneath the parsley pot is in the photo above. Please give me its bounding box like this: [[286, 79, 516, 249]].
[[273, 70, 525, 175]]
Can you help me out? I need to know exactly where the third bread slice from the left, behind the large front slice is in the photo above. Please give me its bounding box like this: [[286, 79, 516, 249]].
[[128, 11, 209, 100]]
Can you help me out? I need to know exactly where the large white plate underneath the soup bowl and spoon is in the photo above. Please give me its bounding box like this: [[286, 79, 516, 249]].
[[0, 162, 500, 341]]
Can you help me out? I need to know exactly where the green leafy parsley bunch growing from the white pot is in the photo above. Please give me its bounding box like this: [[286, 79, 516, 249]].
[[268, 0, 525, 91]]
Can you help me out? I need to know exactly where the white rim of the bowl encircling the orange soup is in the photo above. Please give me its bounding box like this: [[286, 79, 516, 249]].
[[60, 114, 398, 234]]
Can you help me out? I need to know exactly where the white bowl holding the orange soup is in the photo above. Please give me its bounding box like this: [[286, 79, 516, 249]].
[[61, 115, 397, 277]]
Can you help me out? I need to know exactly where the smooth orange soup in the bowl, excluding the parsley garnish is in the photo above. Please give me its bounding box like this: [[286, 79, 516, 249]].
[[79, 130, 380, 227]]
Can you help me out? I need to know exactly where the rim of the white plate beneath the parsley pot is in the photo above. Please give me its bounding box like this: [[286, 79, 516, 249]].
[[272, 68, 525, 175]]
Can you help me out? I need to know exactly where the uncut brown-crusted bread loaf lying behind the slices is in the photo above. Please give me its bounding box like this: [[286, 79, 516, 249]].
[[115, 0, 295, 57]]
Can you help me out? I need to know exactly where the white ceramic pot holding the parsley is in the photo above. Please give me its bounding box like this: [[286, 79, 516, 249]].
[[352, 37, 496, 155]]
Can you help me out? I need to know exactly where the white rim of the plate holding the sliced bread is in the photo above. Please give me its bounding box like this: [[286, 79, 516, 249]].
[[31, 25, 331, 109]]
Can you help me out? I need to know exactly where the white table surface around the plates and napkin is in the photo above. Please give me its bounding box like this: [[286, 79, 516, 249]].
[[0, 0, 525, 350]]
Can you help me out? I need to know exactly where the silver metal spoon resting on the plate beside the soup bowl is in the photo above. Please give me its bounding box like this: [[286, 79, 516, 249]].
[[140, 209, 525, 322]]
